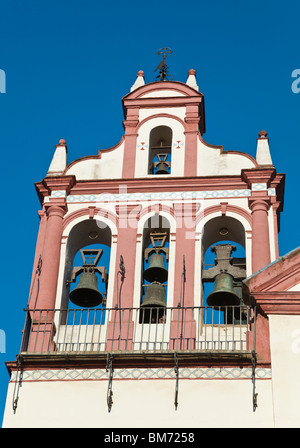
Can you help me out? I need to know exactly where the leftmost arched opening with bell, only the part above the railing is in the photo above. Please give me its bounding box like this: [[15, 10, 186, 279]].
[[61, 219, 112, 309]]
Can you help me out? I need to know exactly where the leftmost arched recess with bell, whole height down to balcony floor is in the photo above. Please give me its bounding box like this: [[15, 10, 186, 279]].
[[55, 219, 111, 352]]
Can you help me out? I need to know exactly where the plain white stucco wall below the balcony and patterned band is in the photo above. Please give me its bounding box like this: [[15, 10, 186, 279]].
[[3, 369, 273, 430]]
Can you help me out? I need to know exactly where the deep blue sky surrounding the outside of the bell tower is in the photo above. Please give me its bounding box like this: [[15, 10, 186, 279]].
[[0, 0, 300, 426]]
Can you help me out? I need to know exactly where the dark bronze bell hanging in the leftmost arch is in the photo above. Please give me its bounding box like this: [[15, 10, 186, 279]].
[[70, 270, 103, 308]]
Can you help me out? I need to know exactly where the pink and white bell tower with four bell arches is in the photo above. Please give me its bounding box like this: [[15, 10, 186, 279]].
[[4, 64, 300, 428]]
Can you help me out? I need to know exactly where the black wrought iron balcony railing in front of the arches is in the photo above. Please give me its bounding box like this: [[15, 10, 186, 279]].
[[20, 306, 255, 355]]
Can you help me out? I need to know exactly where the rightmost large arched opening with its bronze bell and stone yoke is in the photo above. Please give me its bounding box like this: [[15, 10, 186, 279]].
[[202, 216, 247, 323]]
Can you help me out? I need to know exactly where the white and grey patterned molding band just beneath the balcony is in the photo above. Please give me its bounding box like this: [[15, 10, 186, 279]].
[[10, 367, 272, 382]]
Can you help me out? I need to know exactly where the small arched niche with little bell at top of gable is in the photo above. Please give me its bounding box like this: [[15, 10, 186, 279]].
[[148, 126, 172, 175]]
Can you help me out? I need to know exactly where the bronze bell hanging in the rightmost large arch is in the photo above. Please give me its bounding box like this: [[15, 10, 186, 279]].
[[207, 273, 240, 307]]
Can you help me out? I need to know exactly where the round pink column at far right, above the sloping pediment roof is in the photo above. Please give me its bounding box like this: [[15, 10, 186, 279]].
[[249, 199, 271, 273]]
